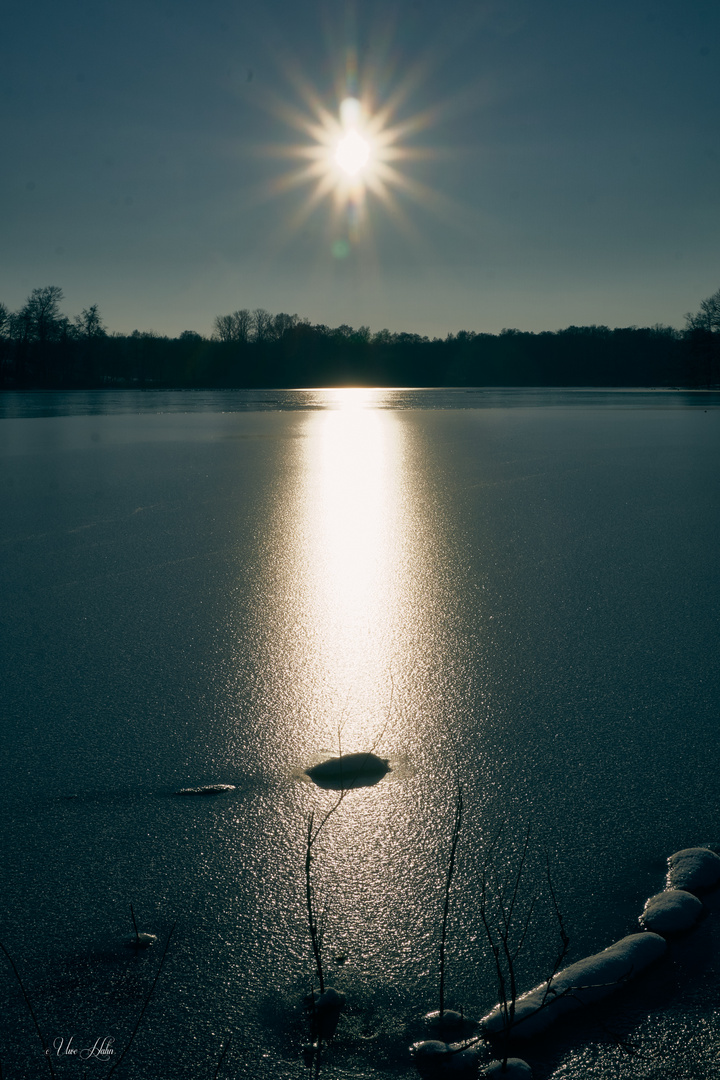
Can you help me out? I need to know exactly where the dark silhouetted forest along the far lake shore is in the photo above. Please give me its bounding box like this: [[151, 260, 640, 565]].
[[0, 285, 720, 390]]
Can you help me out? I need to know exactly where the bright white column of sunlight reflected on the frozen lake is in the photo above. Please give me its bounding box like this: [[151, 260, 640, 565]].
[[305, 388, 400, 751]]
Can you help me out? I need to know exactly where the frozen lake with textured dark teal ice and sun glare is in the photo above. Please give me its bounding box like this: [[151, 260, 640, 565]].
[[0, 390, 720, 1080]]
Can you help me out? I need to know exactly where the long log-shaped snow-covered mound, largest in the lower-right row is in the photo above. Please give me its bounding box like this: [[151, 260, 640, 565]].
[[481, 933, 667, 1039]]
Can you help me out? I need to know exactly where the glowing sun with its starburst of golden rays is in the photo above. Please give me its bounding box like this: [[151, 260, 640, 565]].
[[255, 50, 459, 258]]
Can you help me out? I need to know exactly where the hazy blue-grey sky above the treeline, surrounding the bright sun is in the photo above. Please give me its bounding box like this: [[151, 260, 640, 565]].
[[0, 0, 720, 336]]
